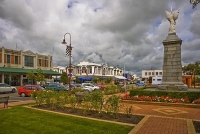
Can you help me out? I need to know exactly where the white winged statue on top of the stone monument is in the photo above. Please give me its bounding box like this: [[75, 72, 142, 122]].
[[165, 9, 180, 34]]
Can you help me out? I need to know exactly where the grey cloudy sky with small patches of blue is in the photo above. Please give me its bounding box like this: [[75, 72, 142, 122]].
[[0, 0, 200, 75]]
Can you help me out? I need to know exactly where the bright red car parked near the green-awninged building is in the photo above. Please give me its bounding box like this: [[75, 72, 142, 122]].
[[18, 85, 44, 97]]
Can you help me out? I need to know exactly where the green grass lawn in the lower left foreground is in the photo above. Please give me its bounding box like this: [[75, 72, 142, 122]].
[[0, 106, 133, 134]]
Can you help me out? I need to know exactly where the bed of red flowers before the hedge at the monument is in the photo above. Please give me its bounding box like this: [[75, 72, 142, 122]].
[[122, 94, 200, 104]]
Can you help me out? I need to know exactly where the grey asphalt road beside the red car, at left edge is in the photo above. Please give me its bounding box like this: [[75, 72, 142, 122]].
[[0, 92, 32, 102]]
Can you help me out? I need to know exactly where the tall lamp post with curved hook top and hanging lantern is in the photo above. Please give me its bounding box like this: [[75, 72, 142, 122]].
[[62, 33, 72, 90]]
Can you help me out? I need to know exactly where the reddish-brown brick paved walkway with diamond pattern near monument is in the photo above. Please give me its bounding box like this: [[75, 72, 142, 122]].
[[0, 100, 200, 134]]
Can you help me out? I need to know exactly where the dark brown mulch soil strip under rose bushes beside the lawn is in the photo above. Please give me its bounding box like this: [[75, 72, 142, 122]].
[[32, 105, 144, 124]]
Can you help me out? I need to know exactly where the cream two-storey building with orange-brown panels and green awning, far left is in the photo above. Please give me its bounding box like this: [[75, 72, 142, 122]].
[[0, 47, 60, 86]]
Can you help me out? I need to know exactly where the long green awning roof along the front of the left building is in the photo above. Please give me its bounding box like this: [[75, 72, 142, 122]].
[[0, 67, 61, 75]]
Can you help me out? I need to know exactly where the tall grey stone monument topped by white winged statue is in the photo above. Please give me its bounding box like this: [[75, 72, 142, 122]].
[[157, 10, 188, 90]]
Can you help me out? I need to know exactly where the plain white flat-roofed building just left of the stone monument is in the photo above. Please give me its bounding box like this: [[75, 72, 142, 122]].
[[142, 70, 163, 79]]
